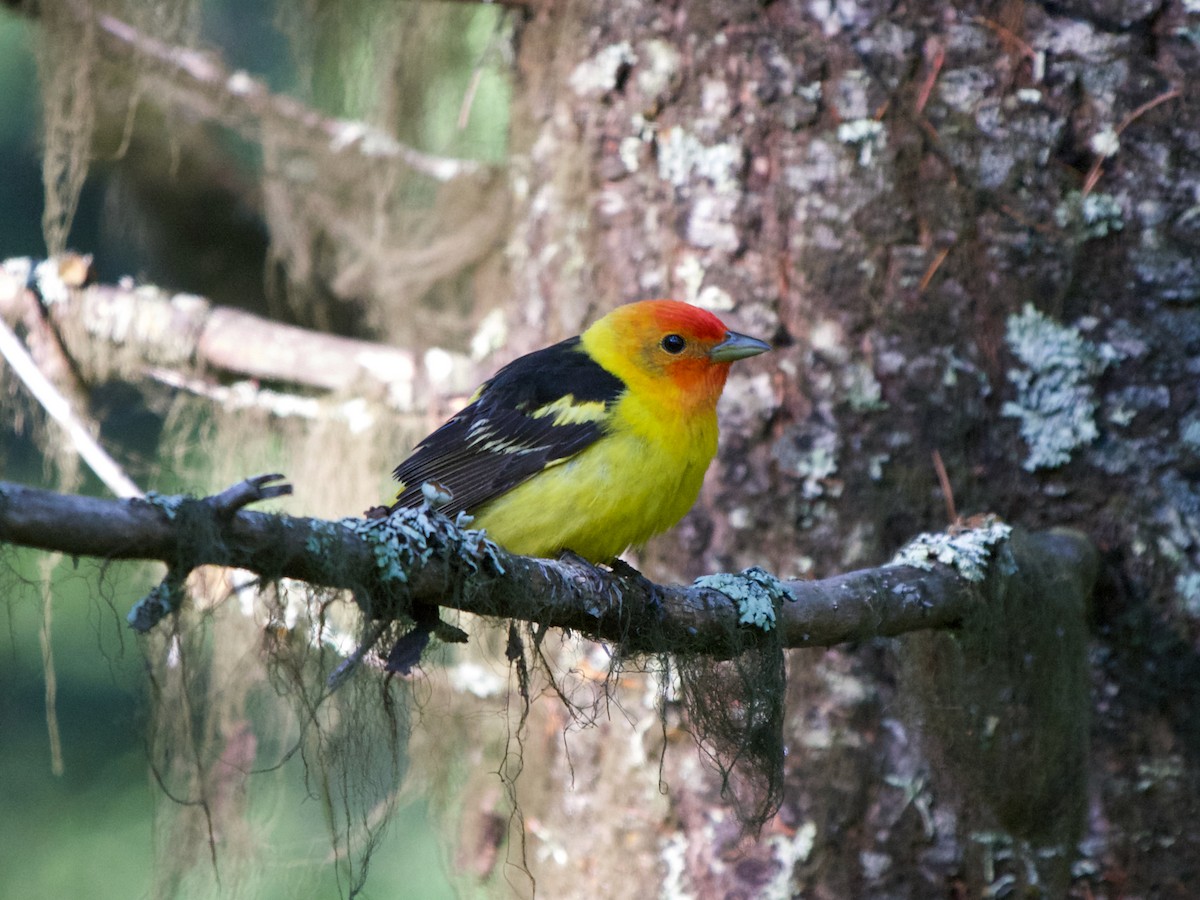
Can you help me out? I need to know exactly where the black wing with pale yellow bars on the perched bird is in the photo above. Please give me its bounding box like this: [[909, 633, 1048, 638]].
[[392, 337, 625, 516]]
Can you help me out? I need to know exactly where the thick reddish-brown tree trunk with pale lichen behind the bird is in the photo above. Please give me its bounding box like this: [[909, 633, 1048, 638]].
[[484, 0, 1200, 896]]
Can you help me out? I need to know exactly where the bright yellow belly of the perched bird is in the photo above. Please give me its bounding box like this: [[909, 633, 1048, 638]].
[[473, 415, 716, 562]]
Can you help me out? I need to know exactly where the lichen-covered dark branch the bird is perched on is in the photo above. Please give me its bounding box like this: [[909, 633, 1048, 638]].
[[0, 475, 1098, 658]]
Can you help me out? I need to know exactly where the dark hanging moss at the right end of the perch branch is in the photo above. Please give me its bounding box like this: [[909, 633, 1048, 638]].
[[901, 530, 1091, 895]]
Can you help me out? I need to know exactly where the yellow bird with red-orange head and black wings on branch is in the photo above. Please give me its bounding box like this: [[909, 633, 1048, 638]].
[[379, 300, 770, 671]]
